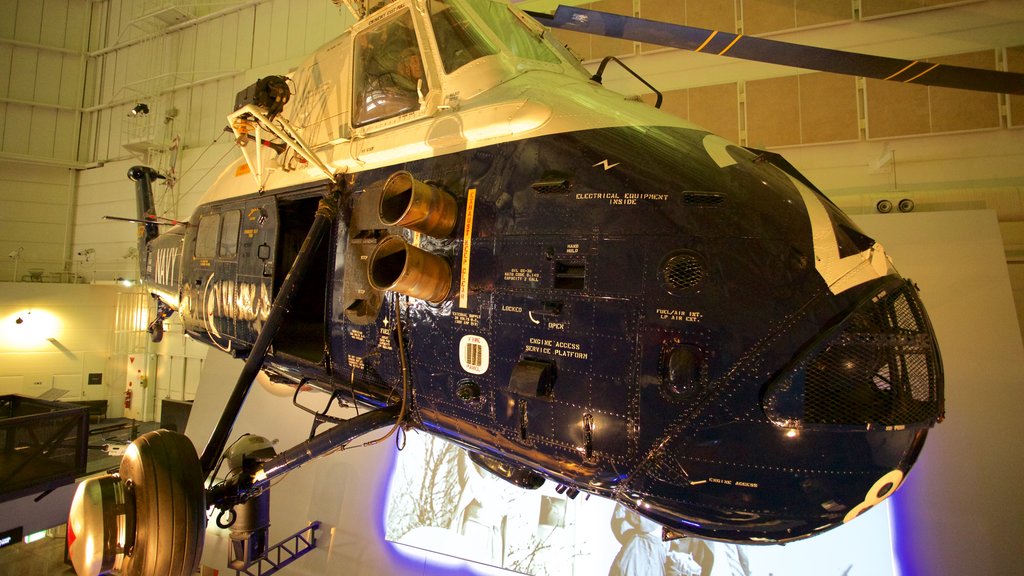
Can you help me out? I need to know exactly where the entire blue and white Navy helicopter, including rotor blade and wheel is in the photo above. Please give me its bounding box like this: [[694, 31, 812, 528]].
[[61, 0, 991, 574]]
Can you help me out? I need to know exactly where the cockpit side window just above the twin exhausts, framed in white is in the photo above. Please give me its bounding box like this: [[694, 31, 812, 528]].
[[352, 10, 429, 126]]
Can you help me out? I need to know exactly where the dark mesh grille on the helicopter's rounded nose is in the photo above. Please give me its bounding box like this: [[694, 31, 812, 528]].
[[762, 282, 943, 426]]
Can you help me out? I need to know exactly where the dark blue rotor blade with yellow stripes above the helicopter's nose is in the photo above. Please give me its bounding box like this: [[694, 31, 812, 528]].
[[529, 6, 1024, 94]]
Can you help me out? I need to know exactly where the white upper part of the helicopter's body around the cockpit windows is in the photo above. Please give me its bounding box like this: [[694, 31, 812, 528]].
[[202, 0, 694, 203]]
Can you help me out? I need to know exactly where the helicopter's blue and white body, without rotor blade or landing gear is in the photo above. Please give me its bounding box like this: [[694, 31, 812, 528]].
[[138, 1, 942, 542]]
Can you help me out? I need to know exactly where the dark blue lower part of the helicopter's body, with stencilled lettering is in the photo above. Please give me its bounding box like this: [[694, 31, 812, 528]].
[[167, 123, 942, 542]]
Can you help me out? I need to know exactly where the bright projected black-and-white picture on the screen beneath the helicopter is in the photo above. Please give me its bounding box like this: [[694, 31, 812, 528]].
[[385, 433, 896, 576]]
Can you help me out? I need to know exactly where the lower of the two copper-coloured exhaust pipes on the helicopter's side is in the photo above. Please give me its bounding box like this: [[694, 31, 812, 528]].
[[368, 236, 452, 303]]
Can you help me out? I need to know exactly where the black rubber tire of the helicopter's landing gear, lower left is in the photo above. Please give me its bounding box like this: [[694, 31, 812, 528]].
[[120, 430, 206, 576]]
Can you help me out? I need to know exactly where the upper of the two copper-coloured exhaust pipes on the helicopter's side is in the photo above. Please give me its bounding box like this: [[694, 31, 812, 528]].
[[378, 170, 459, 238]]
